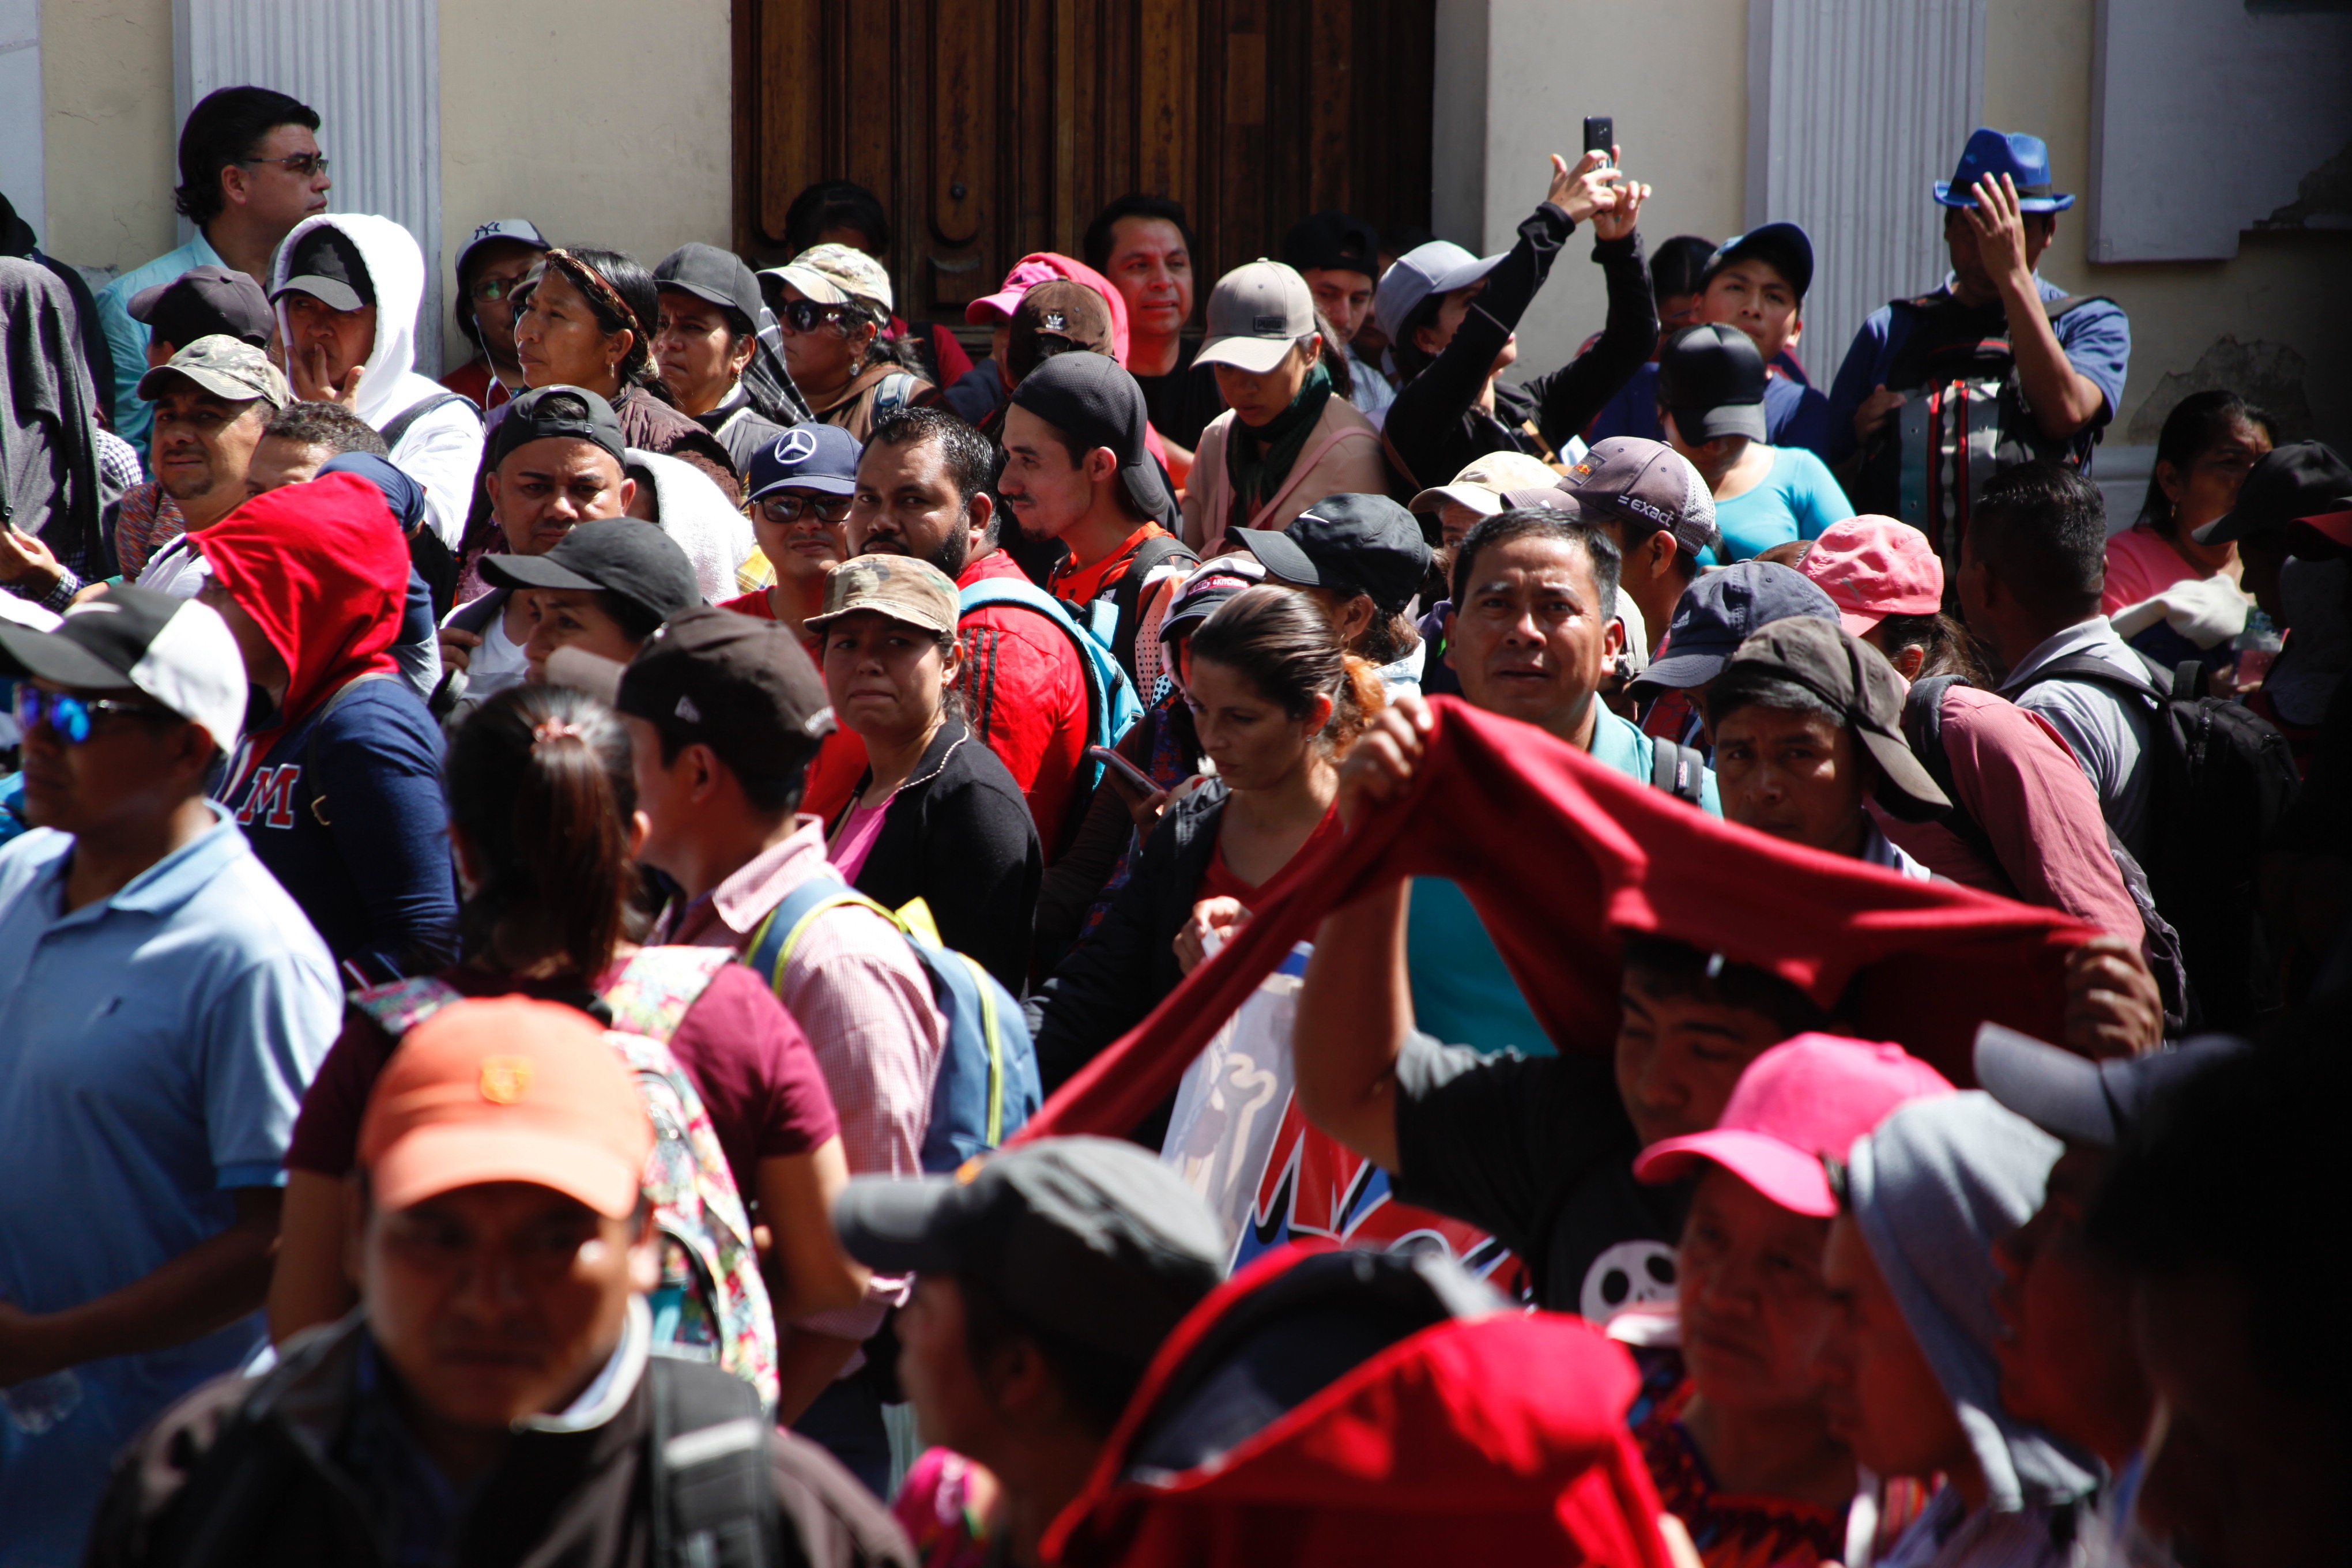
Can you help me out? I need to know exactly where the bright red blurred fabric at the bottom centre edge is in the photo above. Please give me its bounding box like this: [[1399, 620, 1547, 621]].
[[1039, 1248, 1670, 1568]]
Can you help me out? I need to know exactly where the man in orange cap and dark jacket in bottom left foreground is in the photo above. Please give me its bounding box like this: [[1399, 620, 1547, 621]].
[[87, 997, 913, 1568]]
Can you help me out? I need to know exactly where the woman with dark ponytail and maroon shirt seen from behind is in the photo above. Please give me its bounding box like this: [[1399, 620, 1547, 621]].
[[268, 684, 863, 1363]]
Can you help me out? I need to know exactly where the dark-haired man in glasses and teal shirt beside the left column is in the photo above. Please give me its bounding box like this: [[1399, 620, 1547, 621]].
[[96, 87, 334, 454]]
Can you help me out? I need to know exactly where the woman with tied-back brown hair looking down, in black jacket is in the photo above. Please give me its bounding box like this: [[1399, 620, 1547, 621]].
[[1030, 585, 1385, 1124]]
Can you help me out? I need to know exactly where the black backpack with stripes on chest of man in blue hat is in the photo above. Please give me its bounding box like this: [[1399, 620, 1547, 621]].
[[1849, 289, 2112, 592]]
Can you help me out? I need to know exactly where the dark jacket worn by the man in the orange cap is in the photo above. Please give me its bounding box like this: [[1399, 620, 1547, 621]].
[[85, 1317, 915, 1568]]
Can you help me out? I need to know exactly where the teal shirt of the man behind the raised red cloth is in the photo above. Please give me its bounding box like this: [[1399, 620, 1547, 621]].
[[1404, 707, 1724, 1056]]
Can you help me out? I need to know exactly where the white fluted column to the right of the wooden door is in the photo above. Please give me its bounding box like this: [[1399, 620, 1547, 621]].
[[1745, 0, 1985, 367]]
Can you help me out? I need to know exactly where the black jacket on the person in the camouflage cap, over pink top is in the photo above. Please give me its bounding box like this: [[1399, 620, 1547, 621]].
[[835, 717, 1045, 997]]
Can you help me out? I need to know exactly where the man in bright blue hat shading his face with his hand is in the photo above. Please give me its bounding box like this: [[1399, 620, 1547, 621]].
[[1825, 129, 2131, 515]]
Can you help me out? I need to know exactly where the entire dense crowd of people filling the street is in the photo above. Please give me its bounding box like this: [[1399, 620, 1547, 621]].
[[0, 87, 2352, 1568]]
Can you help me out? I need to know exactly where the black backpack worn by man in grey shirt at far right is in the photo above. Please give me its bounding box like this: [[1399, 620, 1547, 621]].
[[2027, 654, 2302, 1034]]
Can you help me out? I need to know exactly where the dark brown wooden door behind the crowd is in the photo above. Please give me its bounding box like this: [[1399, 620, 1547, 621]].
[[736, 0, 1435, 341]]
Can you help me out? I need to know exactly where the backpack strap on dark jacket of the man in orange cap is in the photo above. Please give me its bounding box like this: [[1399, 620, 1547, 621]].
[[644, 1356, 786, 1568]]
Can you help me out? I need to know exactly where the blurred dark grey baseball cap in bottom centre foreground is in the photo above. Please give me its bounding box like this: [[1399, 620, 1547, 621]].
[[832, 1138, 1232, 1363]]
